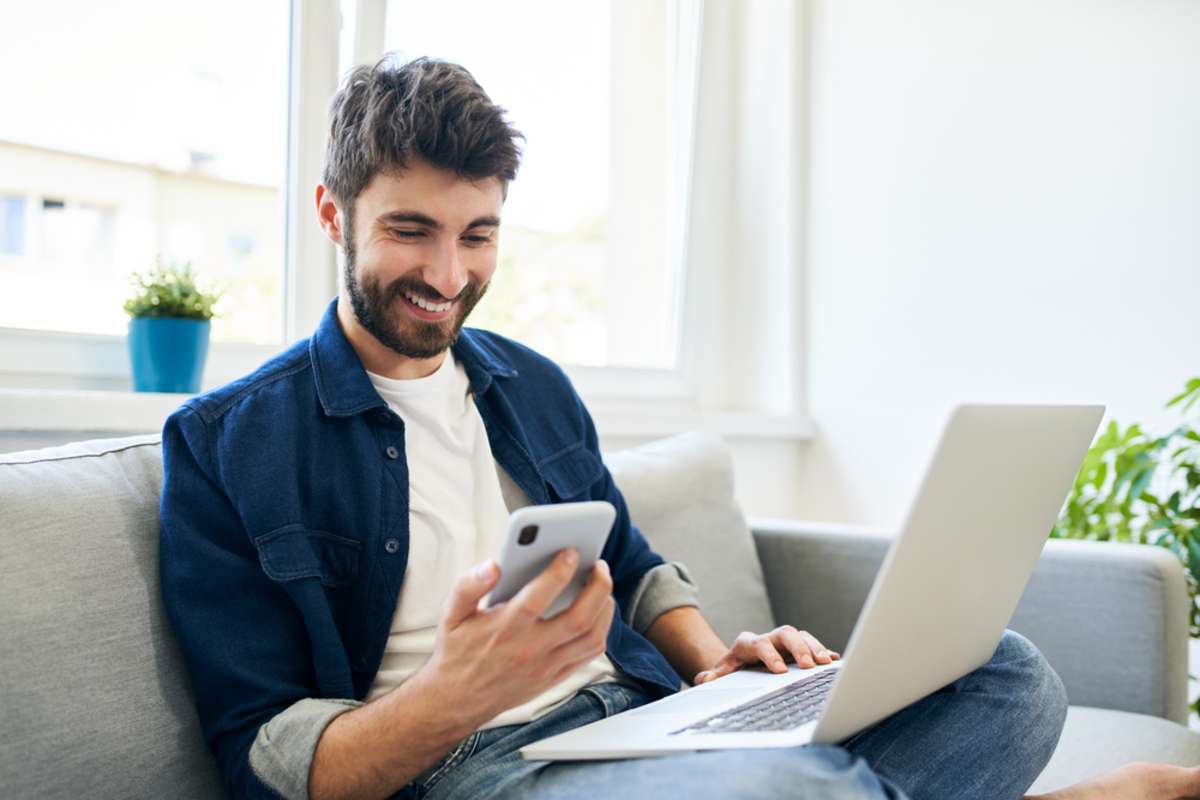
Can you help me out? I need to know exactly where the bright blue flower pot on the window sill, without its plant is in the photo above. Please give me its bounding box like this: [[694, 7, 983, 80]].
[[128, 317, 211, 393]]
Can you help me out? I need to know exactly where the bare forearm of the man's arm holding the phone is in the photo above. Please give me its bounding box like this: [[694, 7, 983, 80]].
[[308, 670, 484, 800]]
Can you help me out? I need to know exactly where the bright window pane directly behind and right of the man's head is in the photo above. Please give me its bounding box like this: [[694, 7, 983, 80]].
[[384, 0, 697, 369]]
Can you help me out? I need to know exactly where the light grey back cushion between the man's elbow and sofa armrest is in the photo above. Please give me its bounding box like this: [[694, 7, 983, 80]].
[[605, 433, 774, 642]]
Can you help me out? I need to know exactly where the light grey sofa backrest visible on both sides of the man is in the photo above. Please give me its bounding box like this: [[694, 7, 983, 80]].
[[0, 434, 772, 799]]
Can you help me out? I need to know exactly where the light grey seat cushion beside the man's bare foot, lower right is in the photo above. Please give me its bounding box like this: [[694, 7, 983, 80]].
[[1031, 705, 1200, 793]]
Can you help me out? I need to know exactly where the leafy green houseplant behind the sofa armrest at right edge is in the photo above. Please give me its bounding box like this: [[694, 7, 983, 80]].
[[1050, 378, 1200, 712]]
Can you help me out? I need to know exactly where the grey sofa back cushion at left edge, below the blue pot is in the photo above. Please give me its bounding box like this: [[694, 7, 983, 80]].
[[0, 435, 222, 798]]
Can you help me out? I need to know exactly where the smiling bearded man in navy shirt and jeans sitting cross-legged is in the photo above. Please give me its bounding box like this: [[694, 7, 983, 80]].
[[161, 59, 1190, 799]]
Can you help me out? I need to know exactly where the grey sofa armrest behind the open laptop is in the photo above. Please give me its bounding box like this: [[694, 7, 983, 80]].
[[750, 519, 1188, 723]]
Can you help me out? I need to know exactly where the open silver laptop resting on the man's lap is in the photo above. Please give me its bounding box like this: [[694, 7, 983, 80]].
[[521, 405, 1104, 760]]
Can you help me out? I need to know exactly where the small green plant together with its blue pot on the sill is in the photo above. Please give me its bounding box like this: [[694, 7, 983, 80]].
[[125, 264, 221, 393]]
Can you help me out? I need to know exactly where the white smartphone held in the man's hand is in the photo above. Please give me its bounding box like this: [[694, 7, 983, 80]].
[[484, 500, 617, 619]]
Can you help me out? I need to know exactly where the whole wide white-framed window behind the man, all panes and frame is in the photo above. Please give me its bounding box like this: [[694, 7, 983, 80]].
[[0, 0, 806, 437]]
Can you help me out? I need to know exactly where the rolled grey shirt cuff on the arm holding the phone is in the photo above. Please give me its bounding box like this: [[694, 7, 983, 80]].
[[243, 698, 362, 800]]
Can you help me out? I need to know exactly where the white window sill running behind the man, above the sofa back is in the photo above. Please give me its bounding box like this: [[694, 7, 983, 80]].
[[0, 389, 816, 441]]
